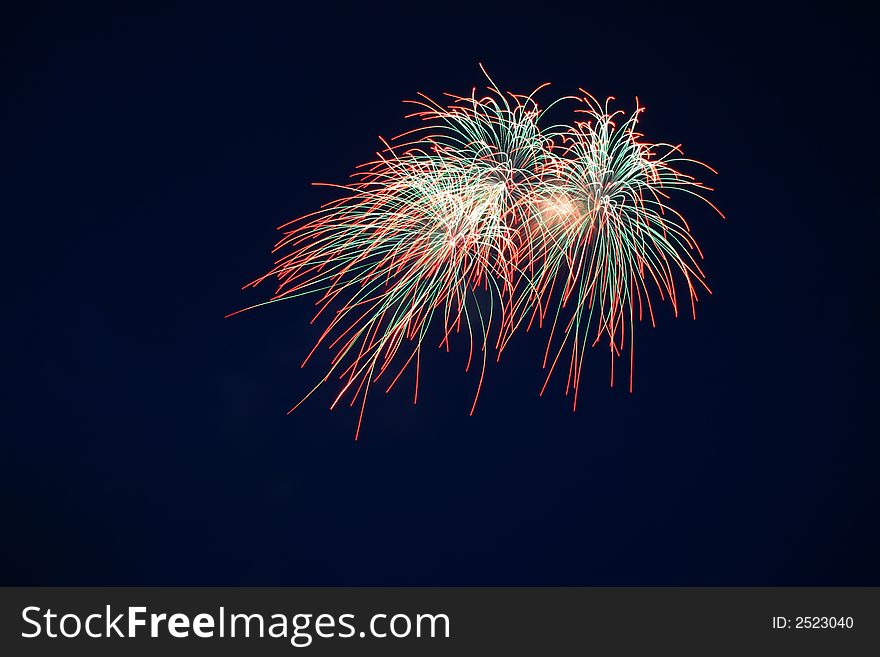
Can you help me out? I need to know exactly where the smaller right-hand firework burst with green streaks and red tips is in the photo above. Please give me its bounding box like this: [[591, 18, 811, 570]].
[[536, 90, 720, 407]]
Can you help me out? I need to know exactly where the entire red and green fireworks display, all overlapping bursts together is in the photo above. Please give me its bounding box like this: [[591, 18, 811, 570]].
[[233, 69, 720, 438]]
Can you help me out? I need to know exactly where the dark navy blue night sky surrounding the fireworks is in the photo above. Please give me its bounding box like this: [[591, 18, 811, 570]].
[[0, 4, 880, 585]]
